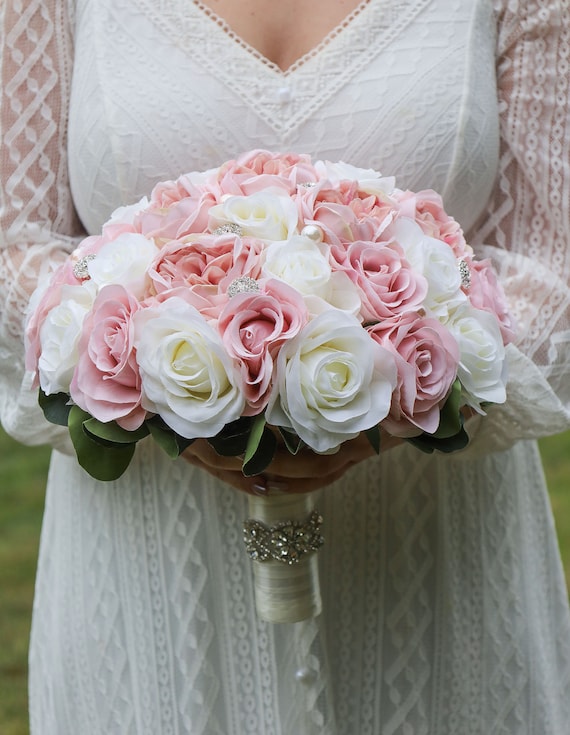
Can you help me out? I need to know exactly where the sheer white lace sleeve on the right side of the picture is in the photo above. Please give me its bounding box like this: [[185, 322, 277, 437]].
[[464, 0, 570, 453]]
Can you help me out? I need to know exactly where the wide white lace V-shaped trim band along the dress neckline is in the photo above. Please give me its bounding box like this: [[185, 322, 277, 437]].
[[136, 0, 424, 137]]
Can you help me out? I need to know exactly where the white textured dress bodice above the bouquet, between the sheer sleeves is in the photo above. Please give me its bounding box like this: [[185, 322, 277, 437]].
[[70, 0, 497, 237]]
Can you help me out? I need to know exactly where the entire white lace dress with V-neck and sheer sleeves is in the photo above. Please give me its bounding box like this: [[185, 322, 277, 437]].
[[0, 0, 570, 735]]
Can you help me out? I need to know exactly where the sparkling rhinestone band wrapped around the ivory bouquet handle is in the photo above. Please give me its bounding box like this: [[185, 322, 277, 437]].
[[243, 510, 324, 564]]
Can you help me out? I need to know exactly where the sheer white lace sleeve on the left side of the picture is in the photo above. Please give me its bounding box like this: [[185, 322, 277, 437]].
[[0, 0, 81, 448]]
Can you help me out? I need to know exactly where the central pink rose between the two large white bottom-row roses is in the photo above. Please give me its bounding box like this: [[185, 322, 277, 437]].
[[218, 279, 308, 415]]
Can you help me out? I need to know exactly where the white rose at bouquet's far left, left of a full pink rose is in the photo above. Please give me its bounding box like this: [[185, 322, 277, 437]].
[[38, 281, 97, 395]]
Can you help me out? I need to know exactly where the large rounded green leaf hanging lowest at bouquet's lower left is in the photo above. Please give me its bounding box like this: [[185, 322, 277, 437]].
[[68, 406, 135, 482]]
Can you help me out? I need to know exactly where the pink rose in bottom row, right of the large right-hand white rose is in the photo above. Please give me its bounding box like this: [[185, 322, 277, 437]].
[[368, 313, 459, 436]]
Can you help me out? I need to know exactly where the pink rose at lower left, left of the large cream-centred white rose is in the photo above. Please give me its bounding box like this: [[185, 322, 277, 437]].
[[70, 285, 146, 431]]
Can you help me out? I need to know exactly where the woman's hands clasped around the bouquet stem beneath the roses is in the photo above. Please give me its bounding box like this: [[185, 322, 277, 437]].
[[182, 432, 402, 495]]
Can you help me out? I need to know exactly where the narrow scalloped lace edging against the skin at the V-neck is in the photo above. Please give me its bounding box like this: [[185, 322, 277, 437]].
[[187, 0, 375, 79]]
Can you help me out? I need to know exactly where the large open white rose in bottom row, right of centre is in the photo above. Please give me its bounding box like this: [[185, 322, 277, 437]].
[[266, 309, 396, 452]]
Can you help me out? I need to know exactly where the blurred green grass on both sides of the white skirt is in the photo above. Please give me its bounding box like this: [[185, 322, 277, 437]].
[[0, 430, 570, 735]]
